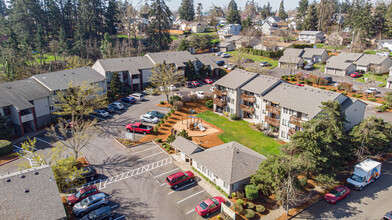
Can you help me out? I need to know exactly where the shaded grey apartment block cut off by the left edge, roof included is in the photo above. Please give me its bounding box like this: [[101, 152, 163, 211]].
[[0, 79, 52, 136]]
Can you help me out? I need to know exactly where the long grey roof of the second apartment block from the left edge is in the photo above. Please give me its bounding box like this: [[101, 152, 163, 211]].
[[31, 67, 105, 92]]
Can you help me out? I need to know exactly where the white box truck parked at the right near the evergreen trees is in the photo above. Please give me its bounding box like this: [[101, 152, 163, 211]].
[[347, 159, 381, 190]]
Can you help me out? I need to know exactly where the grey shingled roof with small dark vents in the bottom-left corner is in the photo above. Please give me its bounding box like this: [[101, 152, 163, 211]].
[[0, 165, 66, 219]]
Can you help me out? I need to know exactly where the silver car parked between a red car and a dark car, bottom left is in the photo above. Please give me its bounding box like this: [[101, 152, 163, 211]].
[[72, 193, 109, 216]]
